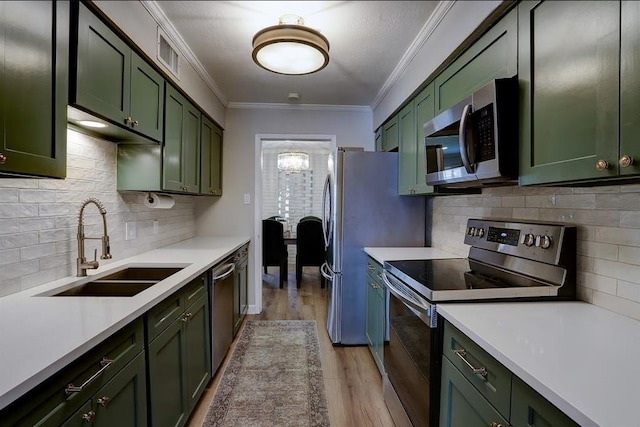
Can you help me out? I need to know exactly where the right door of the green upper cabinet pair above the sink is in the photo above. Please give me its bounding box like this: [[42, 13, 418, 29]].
[[130, 52, 164, 141]]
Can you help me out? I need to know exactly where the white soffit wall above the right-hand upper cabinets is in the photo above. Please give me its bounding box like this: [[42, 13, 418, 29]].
[[373, 0, 502, 128]]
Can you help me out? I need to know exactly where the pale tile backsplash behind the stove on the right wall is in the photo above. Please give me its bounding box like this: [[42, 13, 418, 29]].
[[427, 185, 640, 320]]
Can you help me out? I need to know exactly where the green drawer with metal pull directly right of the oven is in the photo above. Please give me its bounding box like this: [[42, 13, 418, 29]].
[[443, 322, 512, 419]]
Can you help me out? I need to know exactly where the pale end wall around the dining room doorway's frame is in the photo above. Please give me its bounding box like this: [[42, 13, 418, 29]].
[[196, 106, 375, 308]]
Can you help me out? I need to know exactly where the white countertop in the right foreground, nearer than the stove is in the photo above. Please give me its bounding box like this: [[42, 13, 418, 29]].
[[437, 301, 640, 427]]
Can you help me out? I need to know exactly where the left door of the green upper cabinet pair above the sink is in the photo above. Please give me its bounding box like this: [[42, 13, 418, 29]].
[[75, 3, 131, 125]]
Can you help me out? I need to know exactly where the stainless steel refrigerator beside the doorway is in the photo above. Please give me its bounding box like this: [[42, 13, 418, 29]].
[[321, 147, 425, 345]]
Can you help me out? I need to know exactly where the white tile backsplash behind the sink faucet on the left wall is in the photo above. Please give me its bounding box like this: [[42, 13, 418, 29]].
[[0, 130, 195, 296]]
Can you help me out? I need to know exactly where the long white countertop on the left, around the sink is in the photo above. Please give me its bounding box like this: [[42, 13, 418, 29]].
[[0, 237, 250, 409]]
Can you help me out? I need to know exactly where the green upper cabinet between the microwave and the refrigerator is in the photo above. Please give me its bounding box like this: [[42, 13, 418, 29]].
[[398, 83, 434, 195]]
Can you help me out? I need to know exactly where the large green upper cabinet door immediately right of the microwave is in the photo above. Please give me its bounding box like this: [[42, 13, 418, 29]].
[[518, 1, 620, 185]]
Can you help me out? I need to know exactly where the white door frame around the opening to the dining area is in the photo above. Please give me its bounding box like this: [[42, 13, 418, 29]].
[[249, 134, 337, 314]]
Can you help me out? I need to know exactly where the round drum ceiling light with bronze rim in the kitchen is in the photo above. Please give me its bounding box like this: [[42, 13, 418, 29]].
[[251, 15, 329, 75]]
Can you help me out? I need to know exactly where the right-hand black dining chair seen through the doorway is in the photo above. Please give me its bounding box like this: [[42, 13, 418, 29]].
[[296, 216, 325, 288]]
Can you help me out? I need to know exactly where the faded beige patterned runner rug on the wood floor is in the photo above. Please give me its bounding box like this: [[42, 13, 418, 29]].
[[203, 320, 329, 427]]
